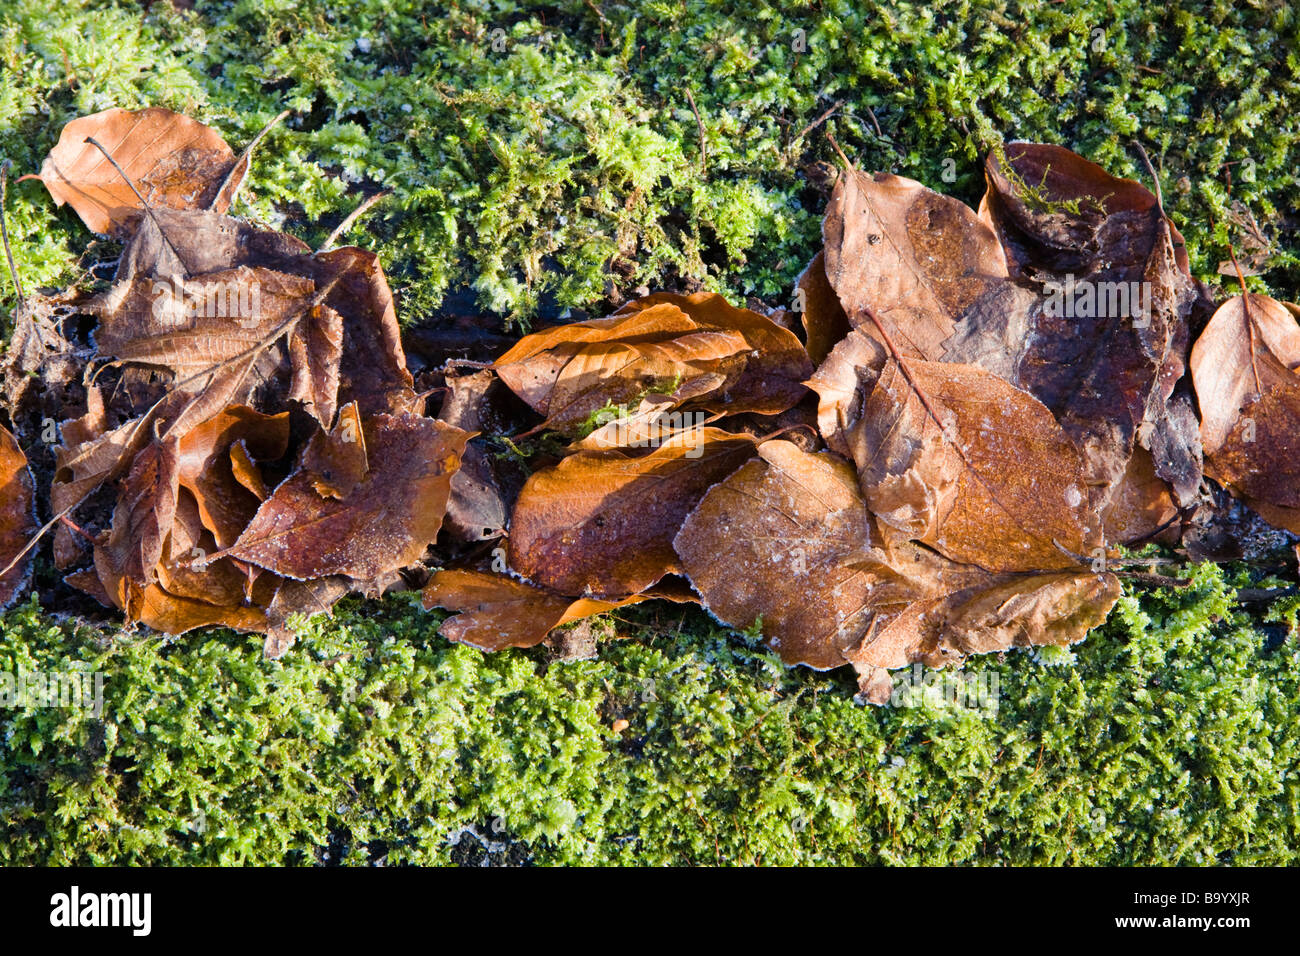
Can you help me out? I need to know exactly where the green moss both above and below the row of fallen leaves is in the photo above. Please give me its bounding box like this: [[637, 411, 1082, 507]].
[[0, 0, 1300, 864]]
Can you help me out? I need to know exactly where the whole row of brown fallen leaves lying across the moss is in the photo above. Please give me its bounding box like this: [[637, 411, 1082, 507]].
[[0, 109, 1300, 701]]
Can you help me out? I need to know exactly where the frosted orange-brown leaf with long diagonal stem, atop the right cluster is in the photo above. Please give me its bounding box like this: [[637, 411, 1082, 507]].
[[810, 330, 1101, 571]]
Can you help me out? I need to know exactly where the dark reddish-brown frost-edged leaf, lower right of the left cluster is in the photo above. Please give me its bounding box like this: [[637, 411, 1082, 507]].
[[229, 412, 469, 580]]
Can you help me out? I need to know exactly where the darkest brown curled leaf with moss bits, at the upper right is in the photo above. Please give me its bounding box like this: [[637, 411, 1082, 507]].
[[980, 143, 1210, 505]]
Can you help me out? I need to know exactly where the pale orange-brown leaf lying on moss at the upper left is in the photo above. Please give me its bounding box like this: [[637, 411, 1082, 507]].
[[27, 107, 235, 234]]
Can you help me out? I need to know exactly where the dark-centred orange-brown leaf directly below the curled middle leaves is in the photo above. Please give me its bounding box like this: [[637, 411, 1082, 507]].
[[510, 428, 754, 597]]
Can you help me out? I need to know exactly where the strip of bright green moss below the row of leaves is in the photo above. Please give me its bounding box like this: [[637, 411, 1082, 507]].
[[0, 567, 1300, 864]]
